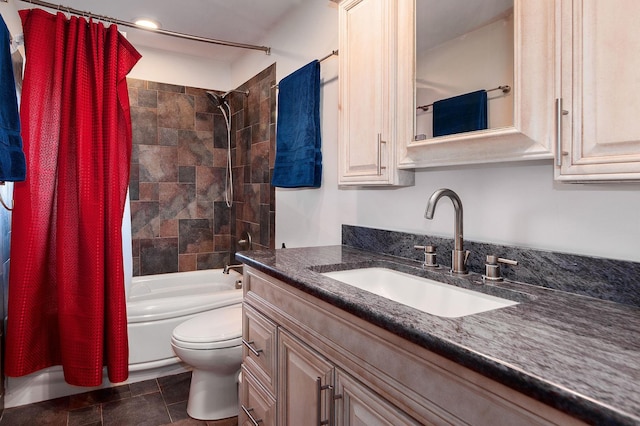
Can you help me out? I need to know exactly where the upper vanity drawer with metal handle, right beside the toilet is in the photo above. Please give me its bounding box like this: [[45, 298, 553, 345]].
[[242, 303, 277, 394]]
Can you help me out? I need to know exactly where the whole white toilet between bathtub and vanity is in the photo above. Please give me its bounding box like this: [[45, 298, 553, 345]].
[[171, 304, 242, 420]]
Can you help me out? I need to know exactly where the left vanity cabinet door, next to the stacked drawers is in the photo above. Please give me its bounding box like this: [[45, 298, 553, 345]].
[[277, 329, 334, 426]]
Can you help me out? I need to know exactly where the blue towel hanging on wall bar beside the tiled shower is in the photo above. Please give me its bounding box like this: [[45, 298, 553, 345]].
[[271, 61, 322, 188]]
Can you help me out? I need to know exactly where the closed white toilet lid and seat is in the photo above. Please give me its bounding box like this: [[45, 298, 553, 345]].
[[171, 305, 242, 350]]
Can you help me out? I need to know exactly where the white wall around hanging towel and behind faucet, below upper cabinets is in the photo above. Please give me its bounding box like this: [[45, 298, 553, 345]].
[[232, 0, 640, 261]]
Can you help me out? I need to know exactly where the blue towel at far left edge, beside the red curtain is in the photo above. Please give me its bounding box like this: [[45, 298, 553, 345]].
[[0, 15, 27, 182]]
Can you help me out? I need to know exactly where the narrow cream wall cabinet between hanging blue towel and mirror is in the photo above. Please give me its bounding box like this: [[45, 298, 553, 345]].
[[338, 0, 414, 186]]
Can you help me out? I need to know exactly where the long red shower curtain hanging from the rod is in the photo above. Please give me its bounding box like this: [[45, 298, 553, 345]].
[[5, 9, 140, 386]]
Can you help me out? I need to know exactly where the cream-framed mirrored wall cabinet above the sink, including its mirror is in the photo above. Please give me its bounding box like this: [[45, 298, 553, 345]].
[[396, 0, 556, 169]]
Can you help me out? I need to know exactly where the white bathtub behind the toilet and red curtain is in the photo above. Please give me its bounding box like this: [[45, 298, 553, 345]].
[[5, 269, 242, 408]]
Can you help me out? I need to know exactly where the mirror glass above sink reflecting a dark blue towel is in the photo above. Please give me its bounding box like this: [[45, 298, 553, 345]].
[[414, 0, 514, 140]]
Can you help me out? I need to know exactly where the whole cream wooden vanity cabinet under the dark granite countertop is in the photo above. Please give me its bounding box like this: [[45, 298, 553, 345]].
[[240, 266, 583, 426]]
